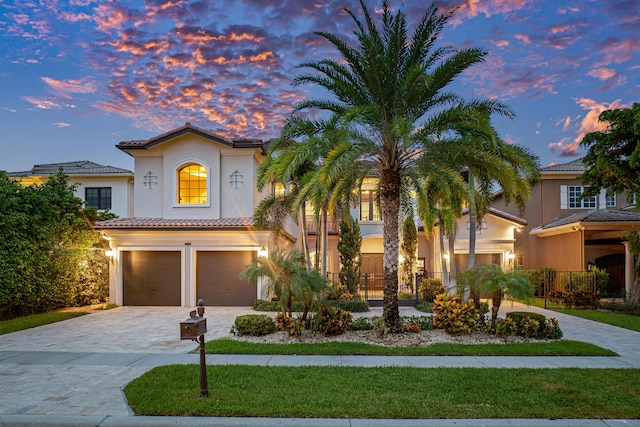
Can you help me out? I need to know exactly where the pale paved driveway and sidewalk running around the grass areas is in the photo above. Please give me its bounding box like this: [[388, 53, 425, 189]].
[[0, 303, 640, 426]]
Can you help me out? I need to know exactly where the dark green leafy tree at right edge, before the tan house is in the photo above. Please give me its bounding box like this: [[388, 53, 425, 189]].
[[580, 103, 640, 301]]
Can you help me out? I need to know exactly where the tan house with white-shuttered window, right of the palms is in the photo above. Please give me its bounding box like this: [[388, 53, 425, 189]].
[[494, 159, 640, 295]]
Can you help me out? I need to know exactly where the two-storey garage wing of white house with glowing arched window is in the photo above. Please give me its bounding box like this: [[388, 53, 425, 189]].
[[95, 123, 295, 307]]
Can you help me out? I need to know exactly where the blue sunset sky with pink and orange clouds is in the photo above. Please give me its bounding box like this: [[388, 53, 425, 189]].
[[0, 0, 640, 172]]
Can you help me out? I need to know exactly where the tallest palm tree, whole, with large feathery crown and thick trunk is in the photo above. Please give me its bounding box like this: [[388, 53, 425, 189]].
[[294, 0, 510, 332]]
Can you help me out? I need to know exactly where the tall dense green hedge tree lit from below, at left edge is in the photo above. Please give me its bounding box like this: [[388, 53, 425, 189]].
[[0, 172, 113, 318]]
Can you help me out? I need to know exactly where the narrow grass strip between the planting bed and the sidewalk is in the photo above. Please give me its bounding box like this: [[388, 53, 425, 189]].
[[206, 338, 617, 356]]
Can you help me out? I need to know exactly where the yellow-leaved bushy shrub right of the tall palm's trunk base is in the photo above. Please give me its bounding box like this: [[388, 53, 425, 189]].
[[433, 294, 480, 335]]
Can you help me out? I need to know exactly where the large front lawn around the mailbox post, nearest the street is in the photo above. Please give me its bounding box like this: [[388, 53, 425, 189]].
[[125, 365, 640, 419]]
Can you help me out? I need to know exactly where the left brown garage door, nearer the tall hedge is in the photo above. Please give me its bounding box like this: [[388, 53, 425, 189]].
[[121, 251, 181, 306]]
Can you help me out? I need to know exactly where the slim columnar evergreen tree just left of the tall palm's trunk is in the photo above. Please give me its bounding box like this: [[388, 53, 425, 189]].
[[338, 219, 362, 295]]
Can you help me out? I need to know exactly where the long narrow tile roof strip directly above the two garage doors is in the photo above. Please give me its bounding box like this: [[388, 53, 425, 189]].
[[94, 217, 253, 230]]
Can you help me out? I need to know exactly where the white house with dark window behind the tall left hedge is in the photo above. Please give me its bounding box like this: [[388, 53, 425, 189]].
[[7, 160, 133, 217]]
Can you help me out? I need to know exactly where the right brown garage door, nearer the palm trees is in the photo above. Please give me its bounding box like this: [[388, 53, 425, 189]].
[[196, 251, 256, 306]]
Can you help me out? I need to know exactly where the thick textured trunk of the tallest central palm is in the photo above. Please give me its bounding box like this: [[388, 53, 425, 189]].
[[380, 169, 402, 333]]
